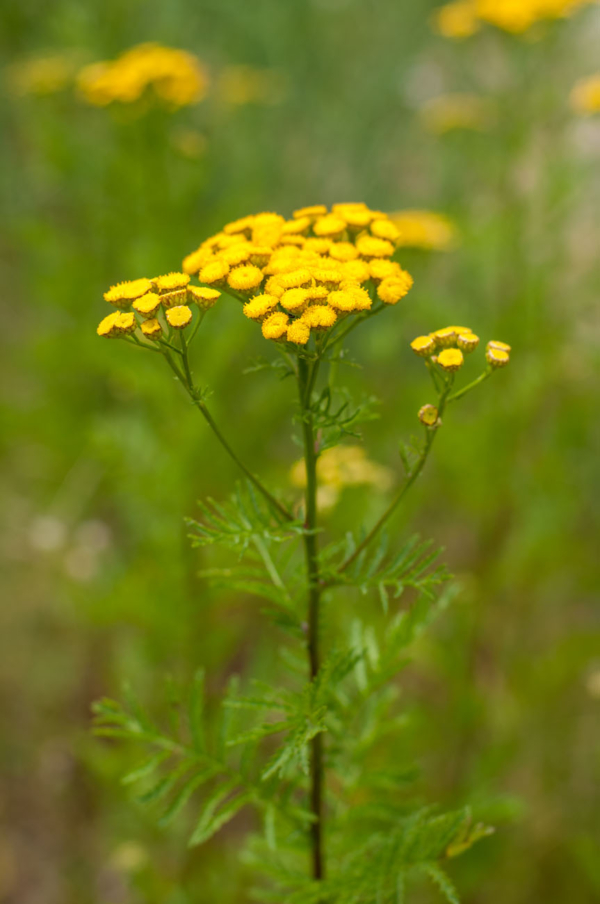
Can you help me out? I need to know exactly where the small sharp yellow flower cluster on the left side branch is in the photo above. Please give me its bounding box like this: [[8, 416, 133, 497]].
[[97, 273, 221, 341]]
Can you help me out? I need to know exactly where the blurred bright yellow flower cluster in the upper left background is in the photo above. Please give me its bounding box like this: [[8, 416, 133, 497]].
[[77, 44, 208, 107]]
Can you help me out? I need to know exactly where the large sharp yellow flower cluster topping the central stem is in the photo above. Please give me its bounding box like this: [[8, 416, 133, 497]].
[[183, 203, 413, 345]]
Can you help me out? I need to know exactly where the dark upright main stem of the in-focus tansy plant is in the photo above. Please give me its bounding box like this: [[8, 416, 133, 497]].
[[298, 358, 325, 879]]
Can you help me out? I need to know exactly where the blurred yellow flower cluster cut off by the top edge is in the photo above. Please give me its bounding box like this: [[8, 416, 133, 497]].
[[434, 0, 596, 38]]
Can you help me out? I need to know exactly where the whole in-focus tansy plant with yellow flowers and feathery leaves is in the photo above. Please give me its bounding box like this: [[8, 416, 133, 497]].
[[96, 204, 510, 904]]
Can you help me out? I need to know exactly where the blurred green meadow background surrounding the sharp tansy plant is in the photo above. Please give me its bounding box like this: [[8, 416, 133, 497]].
[[0, 0, 600, 904]]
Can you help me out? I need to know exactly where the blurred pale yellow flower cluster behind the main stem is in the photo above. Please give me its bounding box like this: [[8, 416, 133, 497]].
[[290, 445, 394, 510]]
